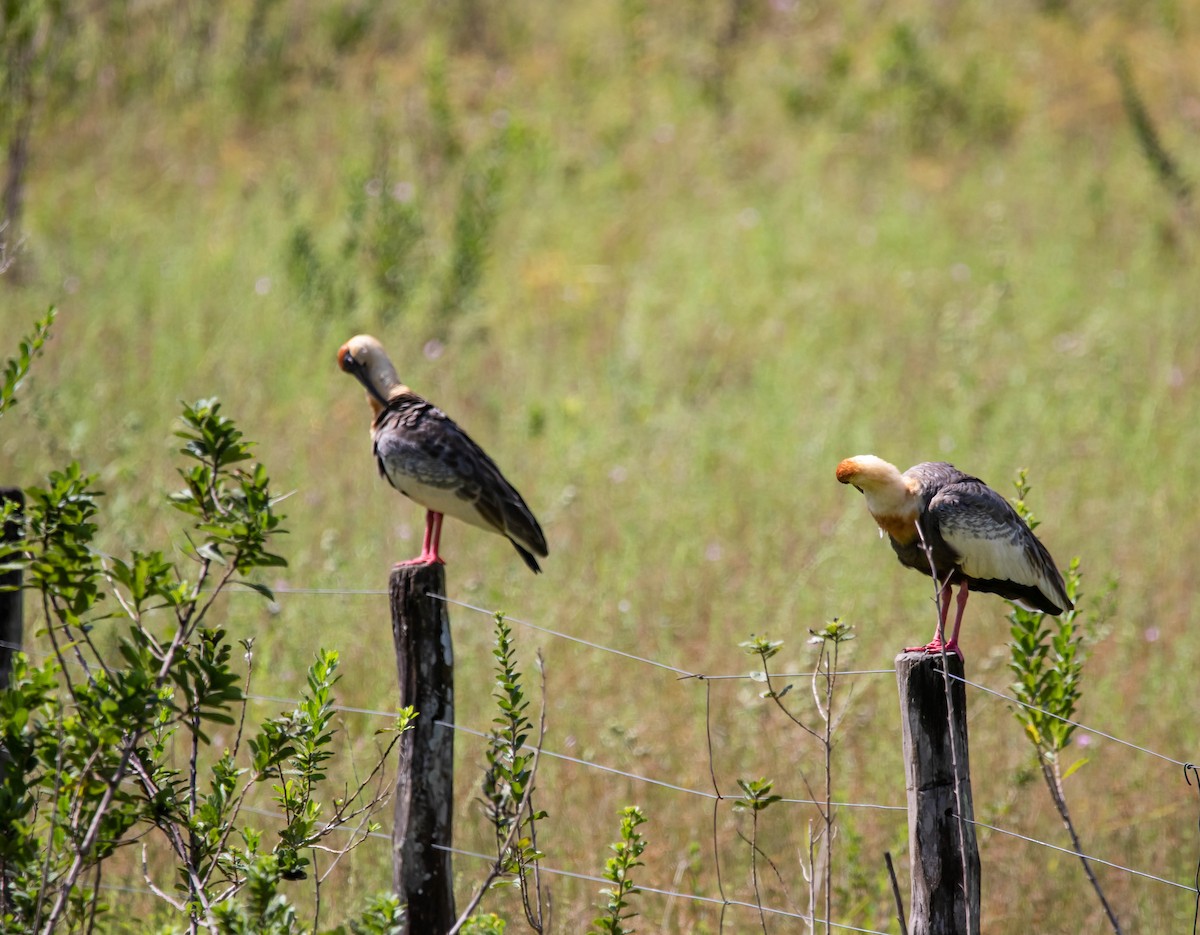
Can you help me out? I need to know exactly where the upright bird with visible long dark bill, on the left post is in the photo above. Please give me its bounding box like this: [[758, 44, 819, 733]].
[[337, 335, 550, 574]]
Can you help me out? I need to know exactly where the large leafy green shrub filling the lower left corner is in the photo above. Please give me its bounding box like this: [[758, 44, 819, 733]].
[[0, 396, 405, 933]]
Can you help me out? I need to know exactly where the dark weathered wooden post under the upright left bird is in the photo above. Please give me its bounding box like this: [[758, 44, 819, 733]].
[[388, 564, 455, 935]]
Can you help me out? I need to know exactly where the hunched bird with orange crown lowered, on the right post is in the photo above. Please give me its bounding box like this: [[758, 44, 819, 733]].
[[838, 455, 1075, 658]]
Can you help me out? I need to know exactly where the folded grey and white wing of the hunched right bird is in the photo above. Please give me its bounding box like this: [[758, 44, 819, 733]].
[[928, 478, 1072, 610]]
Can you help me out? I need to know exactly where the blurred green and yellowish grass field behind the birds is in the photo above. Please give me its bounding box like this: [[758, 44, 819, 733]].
[[0, 2, 1200, 933]]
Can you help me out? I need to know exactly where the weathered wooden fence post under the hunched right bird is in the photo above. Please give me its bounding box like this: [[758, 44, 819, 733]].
[[895, 652, 979, 935]]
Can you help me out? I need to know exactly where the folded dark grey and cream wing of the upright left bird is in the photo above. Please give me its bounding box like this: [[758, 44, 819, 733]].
[[372, 394, 547, 556]]
